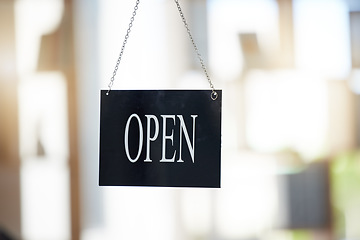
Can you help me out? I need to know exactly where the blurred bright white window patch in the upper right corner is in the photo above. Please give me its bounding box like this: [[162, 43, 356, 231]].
[[294, 0, 351, 79]]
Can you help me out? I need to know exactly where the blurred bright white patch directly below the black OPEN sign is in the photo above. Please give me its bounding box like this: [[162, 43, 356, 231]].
[[102, 187, 176, 240]]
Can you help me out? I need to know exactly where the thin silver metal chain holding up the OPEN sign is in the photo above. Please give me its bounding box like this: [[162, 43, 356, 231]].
[[106, 0, 218, 101]]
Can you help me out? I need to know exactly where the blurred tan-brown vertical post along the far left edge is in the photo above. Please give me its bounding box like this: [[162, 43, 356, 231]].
[[0, 0, 21, 238]]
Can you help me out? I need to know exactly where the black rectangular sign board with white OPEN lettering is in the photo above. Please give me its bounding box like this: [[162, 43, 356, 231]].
[[99, 90, 222, 188]]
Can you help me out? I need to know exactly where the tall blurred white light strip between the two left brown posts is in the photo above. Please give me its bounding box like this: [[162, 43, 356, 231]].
[[15, 0, 71, 240]]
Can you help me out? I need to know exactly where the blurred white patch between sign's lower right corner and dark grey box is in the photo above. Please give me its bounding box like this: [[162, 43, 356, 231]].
[[215, 152, 276, 239]]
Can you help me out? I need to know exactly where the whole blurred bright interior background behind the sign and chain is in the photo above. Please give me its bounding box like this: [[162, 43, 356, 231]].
[[0, 0, 360, 240]]
